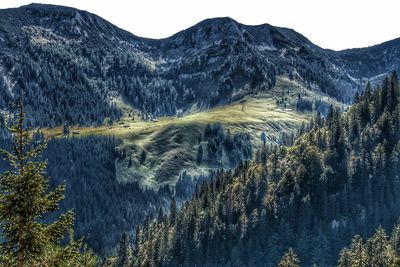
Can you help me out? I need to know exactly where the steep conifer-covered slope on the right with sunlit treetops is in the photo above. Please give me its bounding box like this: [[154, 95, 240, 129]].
[[132, 73, 400, 266]]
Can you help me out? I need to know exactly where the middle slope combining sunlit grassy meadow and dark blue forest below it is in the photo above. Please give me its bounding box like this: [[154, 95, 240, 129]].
[[0, 77, 318, 253]]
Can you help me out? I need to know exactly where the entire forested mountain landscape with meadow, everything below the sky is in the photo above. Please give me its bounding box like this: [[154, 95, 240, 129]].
[[0, 4, 400, 267]]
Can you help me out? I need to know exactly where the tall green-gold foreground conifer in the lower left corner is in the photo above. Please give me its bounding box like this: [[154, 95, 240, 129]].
[[0, 103, 96, 267]]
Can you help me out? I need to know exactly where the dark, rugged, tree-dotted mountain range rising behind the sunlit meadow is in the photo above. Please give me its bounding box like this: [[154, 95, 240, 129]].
[[0, 4, 399, 126]]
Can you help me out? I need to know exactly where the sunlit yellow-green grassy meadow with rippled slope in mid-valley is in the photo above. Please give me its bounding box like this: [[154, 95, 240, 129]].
[[35, 77, 328, 188]]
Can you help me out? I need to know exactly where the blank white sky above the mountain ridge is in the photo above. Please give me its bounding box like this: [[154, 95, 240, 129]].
[[0, 0, 400, 50]]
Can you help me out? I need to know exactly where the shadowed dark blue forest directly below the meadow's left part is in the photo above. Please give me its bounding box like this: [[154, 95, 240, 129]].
[[0, 134, 172, 255]]
